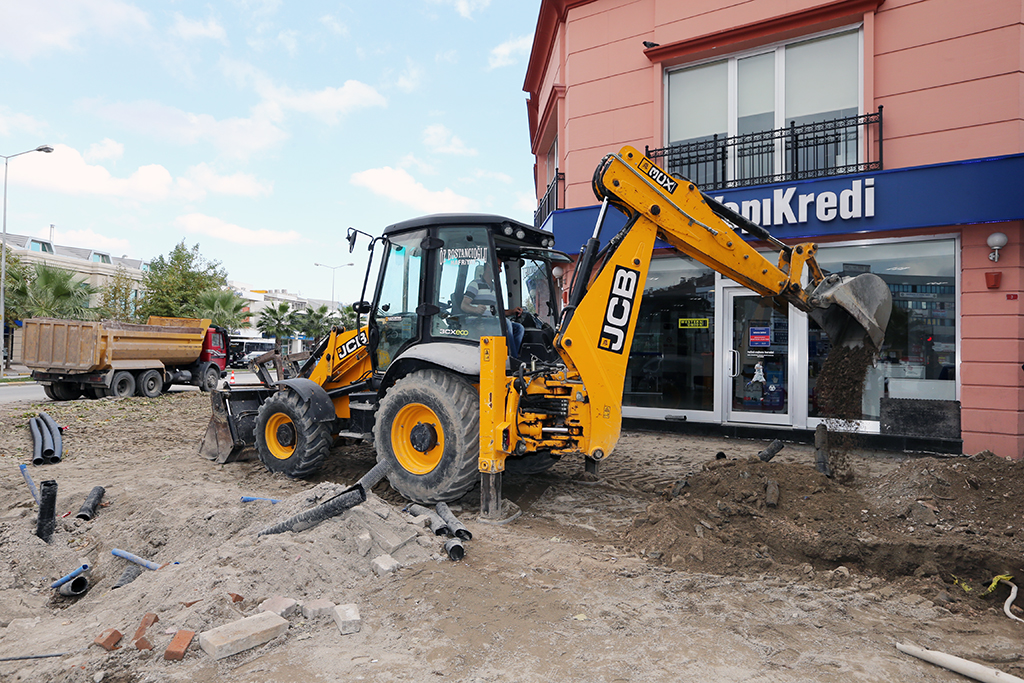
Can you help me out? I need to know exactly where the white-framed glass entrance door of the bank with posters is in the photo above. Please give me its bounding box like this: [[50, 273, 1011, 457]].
[[725, 289, 793, 425]]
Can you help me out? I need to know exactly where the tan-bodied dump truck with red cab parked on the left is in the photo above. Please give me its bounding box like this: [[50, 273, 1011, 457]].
[[22, 315, 227, 400]]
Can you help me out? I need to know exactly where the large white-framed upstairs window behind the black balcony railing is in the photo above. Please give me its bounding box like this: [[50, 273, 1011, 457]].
[[666, 29, 862, 184]]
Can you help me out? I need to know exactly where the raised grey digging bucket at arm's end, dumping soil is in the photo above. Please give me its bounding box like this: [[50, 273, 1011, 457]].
[[809, 272, 893, 351]]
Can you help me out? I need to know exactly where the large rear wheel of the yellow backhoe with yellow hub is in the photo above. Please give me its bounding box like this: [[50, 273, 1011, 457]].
[[374, 370, 480, 504]]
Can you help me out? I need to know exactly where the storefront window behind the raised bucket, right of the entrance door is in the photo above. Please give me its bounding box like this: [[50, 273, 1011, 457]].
[[808, 240, 957, 420]]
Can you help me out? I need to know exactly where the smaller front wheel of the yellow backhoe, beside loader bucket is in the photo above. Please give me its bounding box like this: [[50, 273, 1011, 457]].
[[256, 390, 331, 479]]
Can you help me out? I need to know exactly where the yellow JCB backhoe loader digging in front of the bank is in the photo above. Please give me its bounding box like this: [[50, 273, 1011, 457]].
[[202, 146, 892, 518]]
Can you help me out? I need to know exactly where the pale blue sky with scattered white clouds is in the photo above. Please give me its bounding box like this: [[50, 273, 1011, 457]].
[[0, 0, 540, 303]]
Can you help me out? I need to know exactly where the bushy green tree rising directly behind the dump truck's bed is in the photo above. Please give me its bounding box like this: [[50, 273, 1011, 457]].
[[139, 240, 227, 318]]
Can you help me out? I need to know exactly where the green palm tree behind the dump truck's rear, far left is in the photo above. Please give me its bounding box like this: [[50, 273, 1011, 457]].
[[11, 263, 99, 321]]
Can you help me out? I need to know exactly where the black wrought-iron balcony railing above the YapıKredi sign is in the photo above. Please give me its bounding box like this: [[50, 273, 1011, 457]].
[[645, 106, 883, 190]]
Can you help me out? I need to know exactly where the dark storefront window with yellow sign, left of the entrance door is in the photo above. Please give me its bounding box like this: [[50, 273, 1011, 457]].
[[624, 256, 715, 411]]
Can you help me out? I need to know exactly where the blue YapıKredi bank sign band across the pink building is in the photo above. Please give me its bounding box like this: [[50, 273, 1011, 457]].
[[546, 155, 1024, 251]]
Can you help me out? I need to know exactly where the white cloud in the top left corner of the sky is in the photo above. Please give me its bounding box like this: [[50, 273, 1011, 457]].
[[0, 0, 150, 61]]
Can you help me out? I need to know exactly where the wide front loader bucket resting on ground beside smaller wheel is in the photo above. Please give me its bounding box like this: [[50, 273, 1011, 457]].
[[199, 385, 273, 464]]
